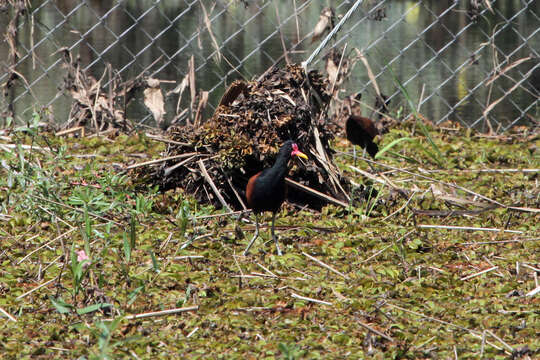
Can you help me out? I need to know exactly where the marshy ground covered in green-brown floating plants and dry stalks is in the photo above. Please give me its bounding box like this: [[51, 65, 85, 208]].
[[0, 123, 540, 359]]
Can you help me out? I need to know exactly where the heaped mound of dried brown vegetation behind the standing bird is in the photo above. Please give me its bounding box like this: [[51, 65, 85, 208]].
[[136, 65, 349, 209]]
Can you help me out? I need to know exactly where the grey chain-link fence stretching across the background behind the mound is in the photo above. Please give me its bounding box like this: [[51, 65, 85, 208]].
[[0, 0, 540, 131]]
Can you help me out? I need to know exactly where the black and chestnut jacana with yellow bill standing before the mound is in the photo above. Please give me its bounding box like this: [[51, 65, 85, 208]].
[[244, 140, 307, 256]]
